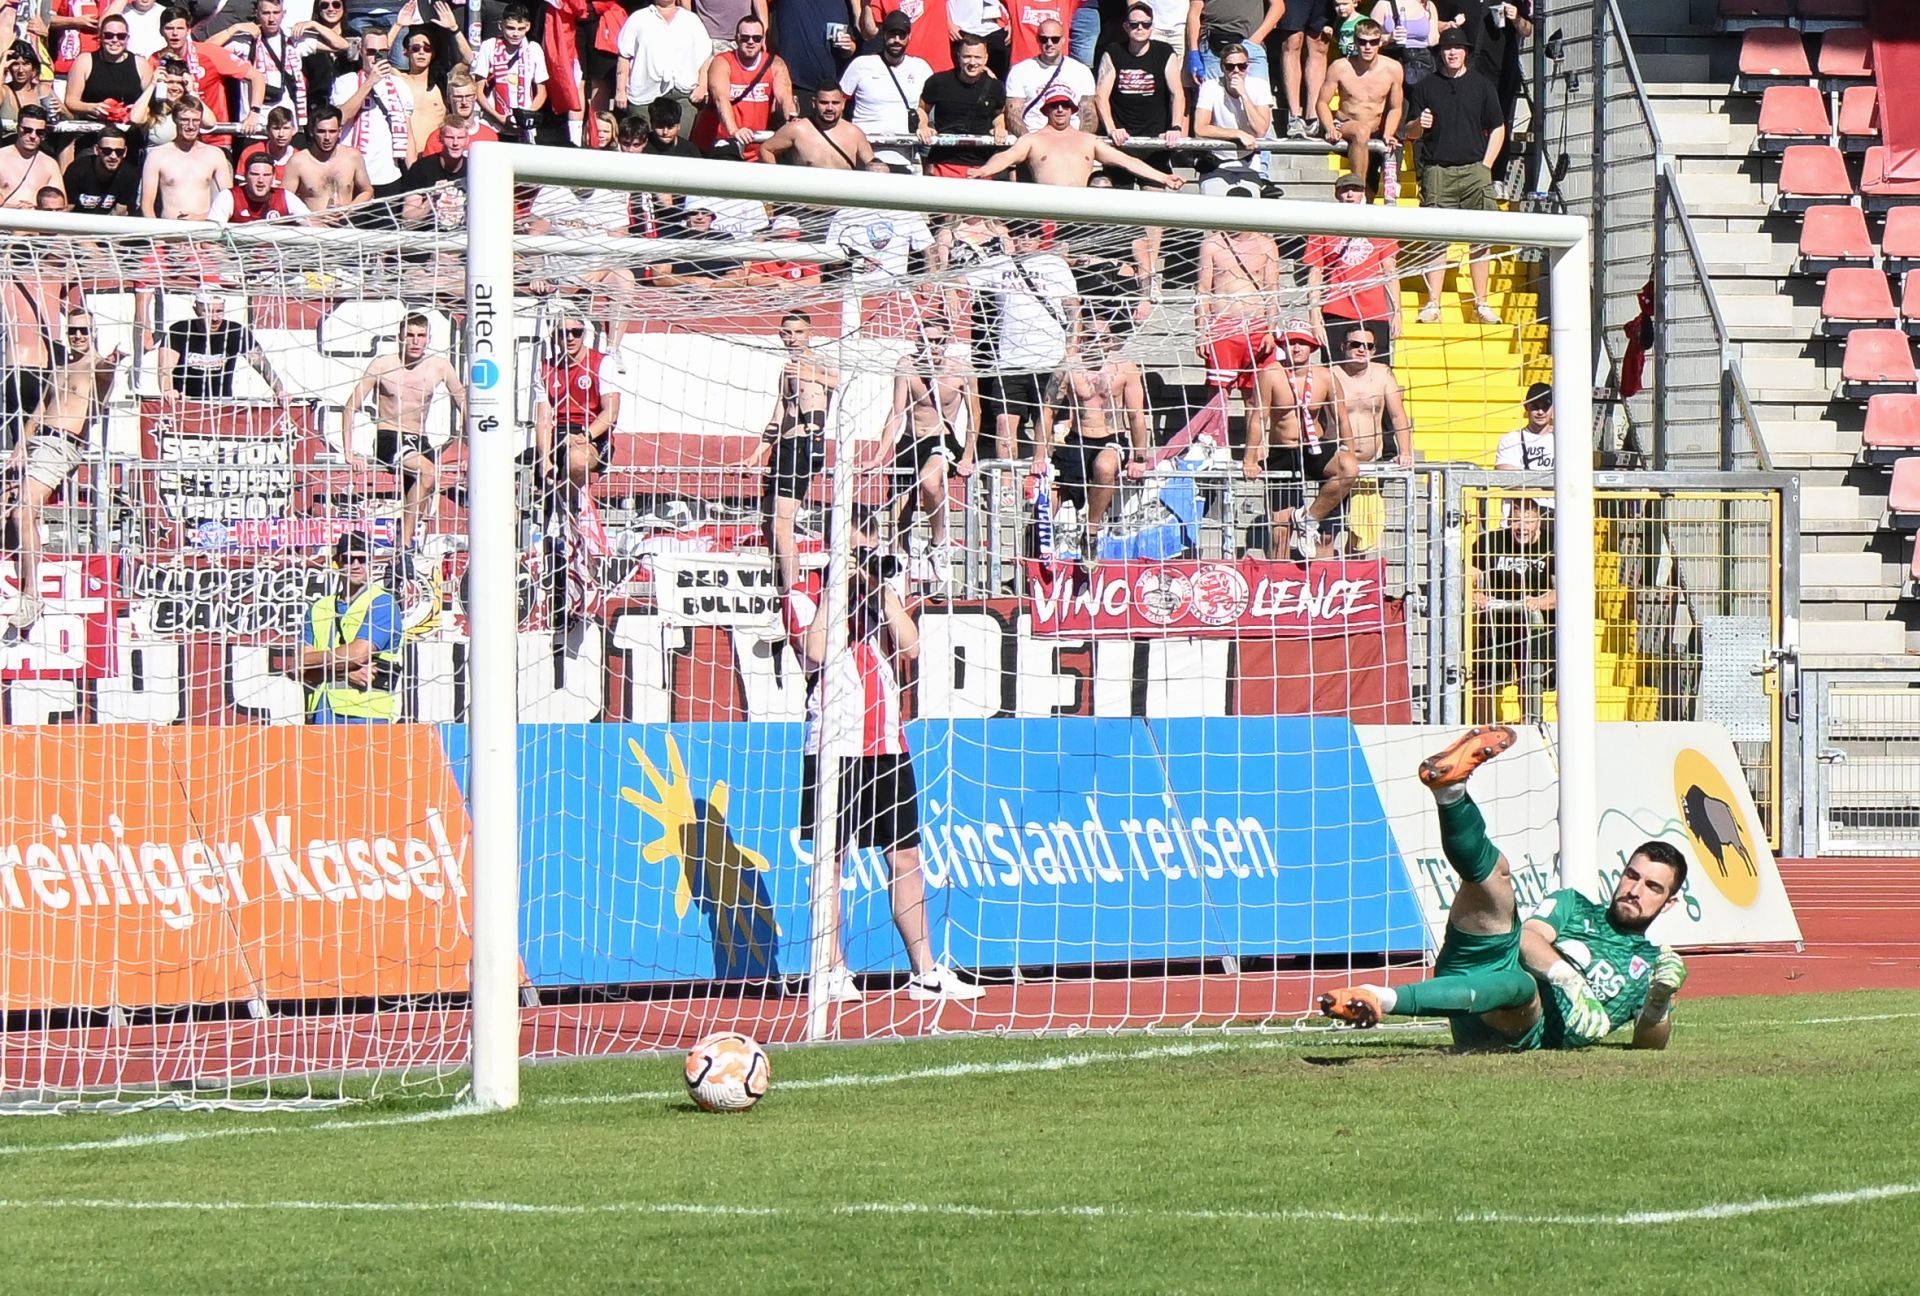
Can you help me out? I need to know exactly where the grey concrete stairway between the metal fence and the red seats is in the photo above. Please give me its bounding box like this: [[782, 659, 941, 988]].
[[1626, 10, 1920, 666]]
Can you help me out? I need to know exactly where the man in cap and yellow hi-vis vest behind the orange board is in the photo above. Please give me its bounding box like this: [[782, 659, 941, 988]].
[[298, 532, 403, 724]]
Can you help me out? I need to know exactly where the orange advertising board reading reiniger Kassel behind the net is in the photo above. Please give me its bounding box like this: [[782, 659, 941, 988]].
[[0, 724, 472, 1012]]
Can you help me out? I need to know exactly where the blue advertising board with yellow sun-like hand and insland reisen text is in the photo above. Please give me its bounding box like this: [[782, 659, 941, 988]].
[[445, 716, 1425, 985]]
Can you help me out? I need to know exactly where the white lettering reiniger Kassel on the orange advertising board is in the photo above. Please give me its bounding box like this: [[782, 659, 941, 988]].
[[0, 808, 467, 931]]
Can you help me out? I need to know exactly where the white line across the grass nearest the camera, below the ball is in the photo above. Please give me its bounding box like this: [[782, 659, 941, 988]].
[[0, 1183, 1920, 1229]]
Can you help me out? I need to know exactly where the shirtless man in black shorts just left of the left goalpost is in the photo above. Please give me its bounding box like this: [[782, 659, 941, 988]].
[[340, 315, 467, 561]]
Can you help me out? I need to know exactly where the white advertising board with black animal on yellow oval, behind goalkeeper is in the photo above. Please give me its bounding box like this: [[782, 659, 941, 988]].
[[1359, 722, 1801, 947]]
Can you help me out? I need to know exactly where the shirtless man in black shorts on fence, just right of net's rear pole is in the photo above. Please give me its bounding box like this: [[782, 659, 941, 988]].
[[868, 311, 987, 584]]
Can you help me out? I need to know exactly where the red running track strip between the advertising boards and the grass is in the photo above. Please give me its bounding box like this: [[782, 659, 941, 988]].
[[11, 858, 1920, 1091]]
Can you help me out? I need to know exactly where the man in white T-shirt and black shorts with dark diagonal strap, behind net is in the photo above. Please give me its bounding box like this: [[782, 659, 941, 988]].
[[966, 221, 1081, 459]]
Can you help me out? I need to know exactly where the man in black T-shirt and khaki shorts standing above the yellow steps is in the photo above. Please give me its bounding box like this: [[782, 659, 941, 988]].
[[1405, 27, 1507, 324]]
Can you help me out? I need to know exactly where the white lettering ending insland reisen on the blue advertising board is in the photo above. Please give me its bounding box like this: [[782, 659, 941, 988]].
[[789, 793, 1281, 895]]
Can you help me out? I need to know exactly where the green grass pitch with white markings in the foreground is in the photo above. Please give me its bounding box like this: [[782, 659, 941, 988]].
[[0, 993, 1920, 1296]]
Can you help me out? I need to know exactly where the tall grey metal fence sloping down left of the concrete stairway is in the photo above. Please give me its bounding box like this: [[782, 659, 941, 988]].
[[1540, 0, 1772, 470]]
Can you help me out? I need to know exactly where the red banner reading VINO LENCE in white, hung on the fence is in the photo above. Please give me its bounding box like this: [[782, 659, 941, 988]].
[[1027, 559, 1386, 639]]
